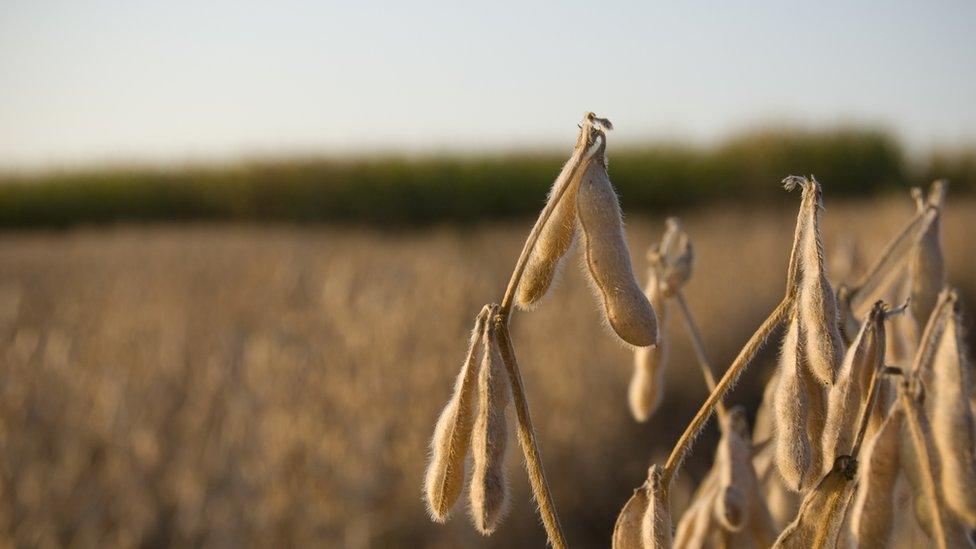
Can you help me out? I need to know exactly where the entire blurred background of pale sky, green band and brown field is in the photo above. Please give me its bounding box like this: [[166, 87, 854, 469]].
[[0, 0, 976, 549]]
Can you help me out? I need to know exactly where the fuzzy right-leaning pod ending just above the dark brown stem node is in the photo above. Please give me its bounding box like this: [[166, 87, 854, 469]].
[[823, 301, 885, 464]]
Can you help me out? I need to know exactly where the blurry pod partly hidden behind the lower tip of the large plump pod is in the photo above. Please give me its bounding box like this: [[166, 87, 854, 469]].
[[627, 272, 670, 421]]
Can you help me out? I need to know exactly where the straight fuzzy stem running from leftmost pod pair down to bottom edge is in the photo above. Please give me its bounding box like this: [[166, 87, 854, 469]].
[[494, 313, 566, 549]]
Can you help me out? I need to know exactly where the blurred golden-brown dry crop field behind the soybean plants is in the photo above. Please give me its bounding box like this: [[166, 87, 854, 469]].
[[0, 189, 976, 547]]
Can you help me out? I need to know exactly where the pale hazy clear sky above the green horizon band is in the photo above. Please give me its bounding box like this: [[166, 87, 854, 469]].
[[0, 0, 976, 168]]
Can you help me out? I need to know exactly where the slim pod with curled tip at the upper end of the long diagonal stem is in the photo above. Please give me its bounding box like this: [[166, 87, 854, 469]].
[[785, 177, 844, 385]]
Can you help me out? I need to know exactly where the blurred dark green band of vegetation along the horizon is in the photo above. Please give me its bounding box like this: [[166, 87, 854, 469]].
[[0, 128, 976, 228]]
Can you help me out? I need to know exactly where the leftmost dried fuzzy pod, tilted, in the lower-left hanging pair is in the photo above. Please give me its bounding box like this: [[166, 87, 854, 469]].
[[424, 308, 488, 522]]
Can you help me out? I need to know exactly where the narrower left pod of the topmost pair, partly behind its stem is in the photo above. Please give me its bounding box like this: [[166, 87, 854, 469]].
[[516, 117, 591, 309]]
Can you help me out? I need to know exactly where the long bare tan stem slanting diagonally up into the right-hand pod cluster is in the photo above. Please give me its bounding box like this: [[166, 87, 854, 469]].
[[661, 293, 793, 495]]
